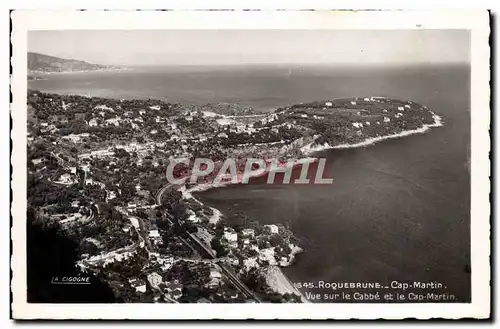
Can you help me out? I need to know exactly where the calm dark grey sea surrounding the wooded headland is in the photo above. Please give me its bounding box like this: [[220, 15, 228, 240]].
[[29, 64, 471, 302]]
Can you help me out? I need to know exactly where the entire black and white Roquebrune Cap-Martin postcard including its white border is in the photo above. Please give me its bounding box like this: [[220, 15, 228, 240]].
[[11, 11, 490, 319]]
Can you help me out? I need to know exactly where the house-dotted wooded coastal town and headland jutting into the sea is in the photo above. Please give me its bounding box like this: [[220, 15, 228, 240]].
[[27, 90, 435, 303]]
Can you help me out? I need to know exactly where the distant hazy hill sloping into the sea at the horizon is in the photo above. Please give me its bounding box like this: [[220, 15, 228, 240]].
[[28, 52, 116, 72]]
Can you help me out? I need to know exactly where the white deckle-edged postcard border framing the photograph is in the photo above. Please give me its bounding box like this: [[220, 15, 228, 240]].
[[11, 10, 490, 319]]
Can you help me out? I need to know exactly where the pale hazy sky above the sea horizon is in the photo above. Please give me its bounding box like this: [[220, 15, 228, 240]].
[[28, 30, 470, 65]]
